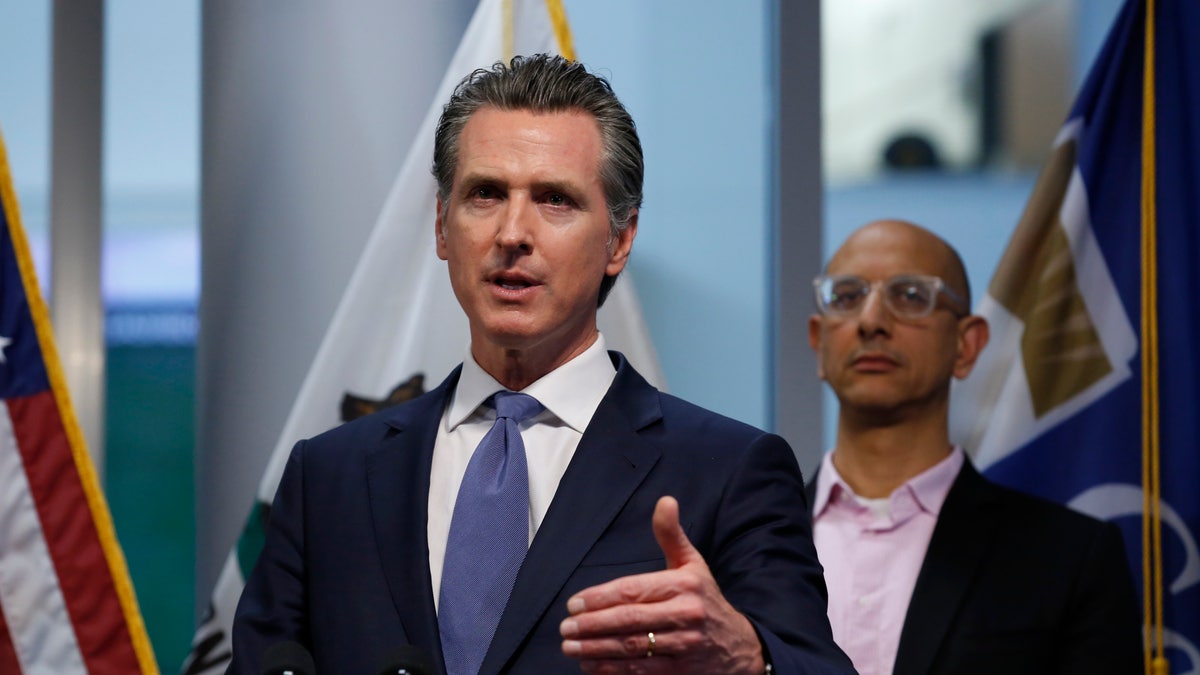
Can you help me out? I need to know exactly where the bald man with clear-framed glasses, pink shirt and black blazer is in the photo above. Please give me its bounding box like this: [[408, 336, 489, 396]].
[[808, 220, 1142, 675]]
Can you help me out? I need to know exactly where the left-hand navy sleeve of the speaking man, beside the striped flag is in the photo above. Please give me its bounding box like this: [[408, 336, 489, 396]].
[[226, 441, 308, 675]]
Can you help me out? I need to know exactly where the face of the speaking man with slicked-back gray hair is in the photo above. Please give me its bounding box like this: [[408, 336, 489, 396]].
[[437, 107, 637, 368]]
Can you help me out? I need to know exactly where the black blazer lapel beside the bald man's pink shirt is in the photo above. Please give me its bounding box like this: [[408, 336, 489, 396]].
[[894, 460, 998, 675]]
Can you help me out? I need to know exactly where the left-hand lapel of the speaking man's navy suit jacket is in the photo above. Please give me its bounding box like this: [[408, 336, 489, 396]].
[[367, 370, 458, 670]]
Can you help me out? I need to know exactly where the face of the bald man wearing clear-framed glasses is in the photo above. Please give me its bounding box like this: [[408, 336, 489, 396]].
[[809, 222, 986, 422]]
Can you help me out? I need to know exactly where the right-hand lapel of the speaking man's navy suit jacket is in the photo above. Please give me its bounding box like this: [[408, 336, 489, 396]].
[[480, 356, 662, 673]]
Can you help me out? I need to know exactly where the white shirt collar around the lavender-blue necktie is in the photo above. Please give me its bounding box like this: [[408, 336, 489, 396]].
[[445, 334, 617, 434]]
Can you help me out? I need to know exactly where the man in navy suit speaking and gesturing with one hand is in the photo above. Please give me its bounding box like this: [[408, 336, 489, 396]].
[[229, 55, 851, 675]]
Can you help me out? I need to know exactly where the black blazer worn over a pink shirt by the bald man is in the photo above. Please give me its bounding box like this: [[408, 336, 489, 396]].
[[809, 460, 1142, 675]]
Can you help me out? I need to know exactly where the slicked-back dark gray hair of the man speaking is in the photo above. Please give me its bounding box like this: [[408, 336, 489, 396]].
[[433, 54, 644, 305]]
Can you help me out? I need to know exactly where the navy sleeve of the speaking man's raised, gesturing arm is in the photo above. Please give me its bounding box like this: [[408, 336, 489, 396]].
[[708, 435, 854, 674]]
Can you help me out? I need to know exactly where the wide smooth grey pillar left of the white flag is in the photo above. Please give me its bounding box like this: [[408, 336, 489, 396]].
[[196, 0, 474, 610]]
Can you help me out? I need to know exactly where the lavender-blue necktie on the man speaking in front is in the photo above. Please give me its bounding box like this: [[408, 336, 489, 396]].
[[438, 392, 542, 675]]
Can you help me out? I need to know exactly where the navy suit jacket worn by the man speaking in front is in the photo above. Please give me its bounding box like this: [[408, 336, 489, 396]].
[[229, 352, 852, 675]]
